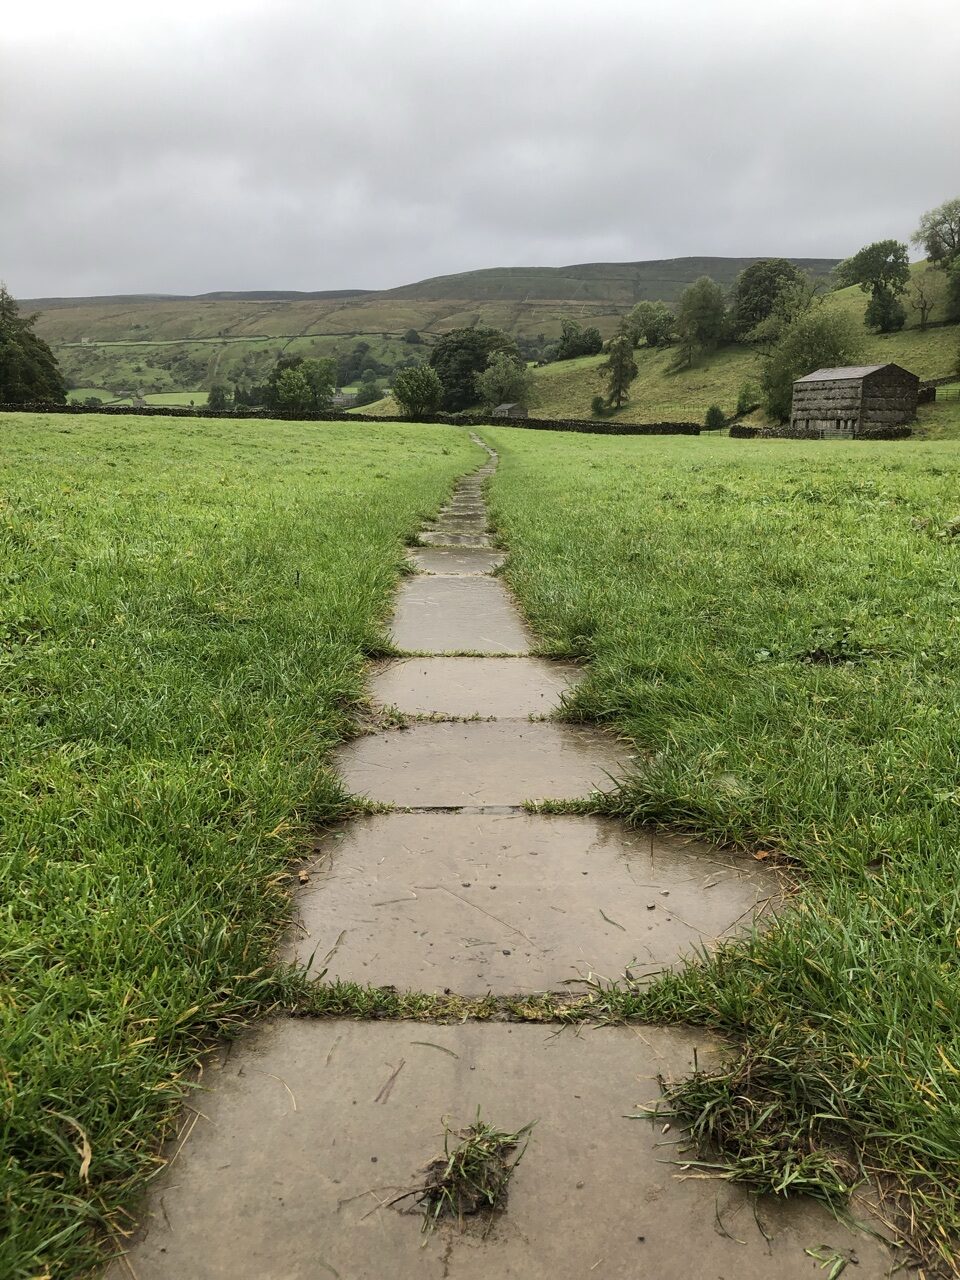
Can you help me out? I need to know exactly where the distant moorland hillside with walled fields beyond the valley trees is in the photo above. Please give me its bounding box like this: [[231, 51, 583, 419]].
[[23, 257, 835, 398]]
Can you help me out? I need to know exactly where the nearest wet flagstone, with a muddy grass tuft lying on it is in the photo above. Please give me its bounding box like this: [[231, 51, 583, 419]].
[[109, 1019, 888, 1280]]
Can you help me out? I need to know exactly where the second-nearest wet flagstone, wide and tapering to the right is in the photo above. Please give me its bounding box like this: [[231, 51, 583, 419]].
[[289, 813, 780, 996]]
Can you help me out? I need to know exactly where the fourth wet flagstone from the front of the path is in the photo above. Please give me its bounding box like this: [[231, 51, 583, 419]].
[[369, 658, 582, 718]]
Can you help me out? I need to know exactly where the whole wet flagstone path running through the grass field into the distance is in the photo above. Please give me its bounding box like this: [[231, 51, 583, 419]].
[[109, 451, 891, 1280]]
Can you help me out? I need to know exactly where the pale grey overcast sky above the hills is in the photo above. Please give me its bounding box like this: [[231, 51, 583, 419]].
[[0, 0, 960, 297]]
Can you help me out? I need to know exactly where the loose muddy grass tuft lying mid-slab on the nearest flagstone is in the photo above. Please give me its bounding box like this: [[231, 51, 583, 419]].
[[392, 1107, 534, 1230]]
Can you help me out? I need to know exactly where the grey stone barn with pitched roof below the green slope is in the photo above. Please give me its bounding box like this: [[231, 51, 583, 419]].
[[790, 365, 920, 439]]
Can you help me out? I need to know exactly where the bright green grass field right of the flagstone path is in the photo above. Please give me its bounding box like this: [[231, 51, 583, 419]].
[[483, 429, 960, 1274]]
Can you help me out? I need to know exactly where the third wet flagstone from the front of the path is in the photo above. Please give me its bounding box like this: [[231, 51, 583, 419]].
[[334, 721, 630, 809]]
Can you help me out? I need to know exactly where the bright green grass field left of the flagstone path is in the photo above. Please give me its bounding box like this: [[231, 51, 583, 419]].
[[0, 415, 484, 1280]]
